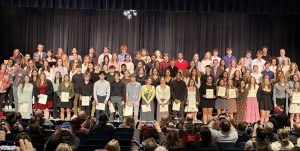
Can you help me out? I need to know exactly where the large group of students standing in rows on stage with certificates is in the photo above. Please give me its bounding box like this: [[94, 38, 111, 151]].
[[0, 44, 300, 127]]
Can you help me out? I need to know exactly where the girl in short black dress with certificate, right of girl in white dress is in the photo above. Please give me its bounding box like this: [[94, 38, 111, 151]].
[[199, 75, 216, 124]]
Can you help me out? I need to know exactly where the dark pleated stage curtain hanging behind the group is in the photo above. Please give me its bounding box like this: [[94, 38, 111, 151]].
[[0, 0, 300, 63]]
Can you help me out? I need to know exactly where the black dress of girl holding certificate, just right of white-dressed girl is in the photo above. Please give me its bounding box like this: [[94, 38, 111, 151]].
[[199, 83, 216, 108]]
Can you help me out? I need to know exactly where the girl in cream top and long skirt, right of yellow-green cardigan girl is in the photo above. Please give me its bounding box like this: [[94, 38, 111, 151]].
[[156, 77, 171, 121]]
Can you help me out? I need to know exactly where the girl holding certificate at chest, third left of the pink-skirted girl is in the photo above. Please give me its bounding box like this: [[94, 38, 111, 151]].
[[215, 78, 227, 115]]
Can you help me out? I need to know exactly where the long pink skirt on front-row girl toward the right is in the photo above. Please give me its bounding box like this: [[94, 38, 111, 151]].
[[245, 97, 260, 123]]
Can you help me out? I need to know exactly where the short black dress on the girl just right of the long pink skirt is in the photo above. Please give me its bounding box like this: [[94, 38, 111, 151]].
[[257, 87, 273, 111]]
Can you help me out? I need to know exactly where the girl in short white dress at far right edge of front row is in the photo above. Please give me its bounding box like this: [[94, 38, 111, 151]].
[[289, 81, 300, 128]]
